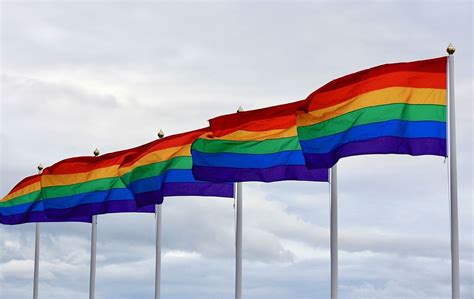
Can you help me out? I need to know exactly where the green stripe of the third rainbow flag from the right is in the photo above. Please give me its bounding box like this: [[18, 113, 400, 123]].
[[122, 156, 193, 185]]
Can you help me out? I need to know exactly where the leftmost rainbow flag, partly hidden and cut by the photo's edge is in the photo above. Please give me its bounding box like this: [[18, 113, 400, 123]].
[[0, 174, 92, 224]]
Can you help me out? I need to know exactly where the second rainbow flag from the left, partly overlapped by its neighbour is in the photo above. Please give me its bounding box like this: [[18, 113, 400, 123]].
[[40, 149, 156, 221]]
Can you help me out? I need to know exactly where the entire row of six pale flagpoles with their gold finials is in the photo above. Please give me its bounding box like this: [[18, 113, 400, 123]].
[[26, 46, 460, 299]]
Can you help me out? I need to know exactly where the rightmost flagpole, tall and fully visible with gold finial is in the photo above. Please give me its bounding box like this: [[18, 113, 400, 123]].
[[446, 44, 460, 299]]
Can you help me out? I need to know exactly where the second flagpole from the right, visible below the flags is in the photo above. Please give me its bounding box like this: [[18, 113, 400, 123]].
[[330, 165, 338, 299]]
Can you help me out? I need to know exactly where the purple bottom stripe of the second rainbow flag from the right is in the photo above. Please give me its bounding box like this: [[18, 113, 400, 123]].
[[193, 165, 329, 183]]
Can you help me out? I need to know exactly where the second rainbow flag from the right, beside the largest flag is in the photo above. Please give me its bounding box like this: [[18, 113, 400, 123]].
[[192, 101, 328, 182]]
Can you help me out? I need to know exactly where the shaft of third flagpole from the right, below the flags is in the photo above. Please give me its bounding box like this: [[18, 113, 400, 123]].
[[235, 183, 242, 299]]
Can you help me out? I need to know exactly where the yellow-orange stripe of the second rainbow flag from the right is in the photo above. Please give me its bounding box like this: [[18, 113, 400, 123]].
[[201, 126, 296, 141]]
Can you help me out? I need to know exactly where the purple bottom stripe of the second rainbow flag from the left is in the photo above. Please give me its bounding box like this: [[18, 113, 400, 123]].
[[46, 200, 155, 221]]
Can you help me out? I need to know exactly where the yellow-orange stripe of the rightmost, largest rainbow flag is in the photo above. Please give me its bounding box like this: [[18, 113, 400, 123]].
[[297, 87, 446, 126]]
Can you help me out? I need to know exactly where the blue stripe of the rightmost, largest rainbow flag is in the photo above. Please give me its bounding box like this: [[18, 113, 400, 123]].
[[300, 120, 446, 154]]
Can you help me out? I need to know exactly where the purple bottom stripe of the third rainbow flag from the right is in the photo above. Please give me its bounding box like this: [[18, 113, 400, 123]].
[[164, 182, 234, 197]]
